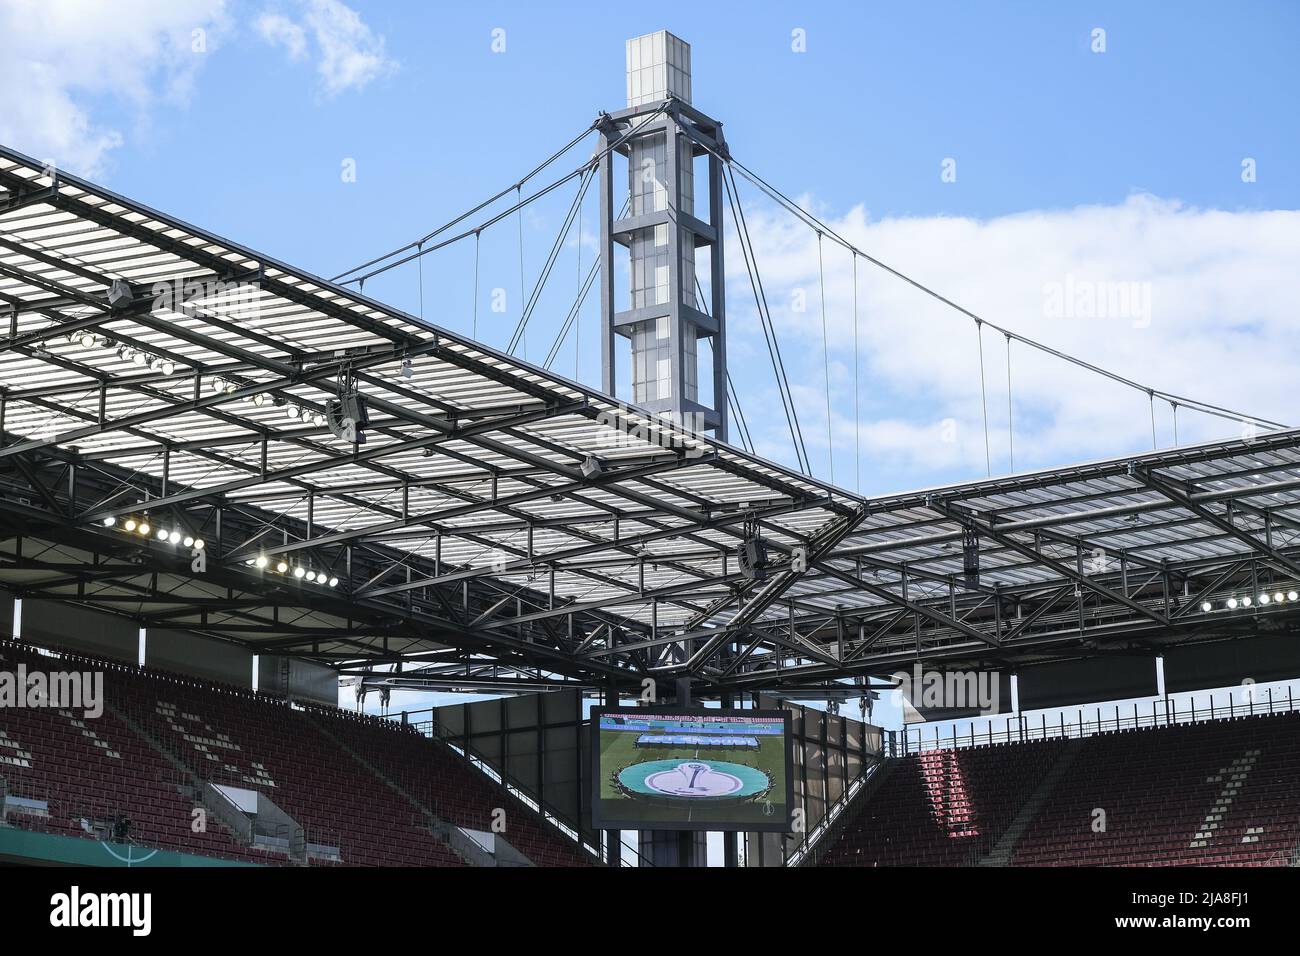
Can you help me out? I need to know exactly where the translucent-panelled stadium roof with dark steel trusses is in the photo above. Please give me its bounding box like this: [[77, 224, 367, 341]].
[[0, 148, 1300, 689]]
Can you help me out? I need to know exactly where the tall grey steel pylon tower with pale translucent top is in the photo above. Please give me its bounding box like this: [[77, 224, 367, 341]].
[[599, 30, 727, 441]]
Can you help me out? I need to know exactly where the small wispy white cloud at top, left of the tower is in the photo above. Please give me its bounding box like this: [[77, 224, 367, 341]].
[[256, 0, 398, 96]]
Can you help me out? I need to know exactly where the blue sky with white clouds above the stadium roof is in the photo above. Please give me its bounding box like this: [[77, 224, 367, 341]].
[[0, 0, 1300, 738]]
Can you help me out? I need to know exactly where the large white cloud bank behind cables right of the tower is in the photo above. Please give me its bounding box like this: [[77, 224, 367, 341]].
[[728, 195, 1300, 490]]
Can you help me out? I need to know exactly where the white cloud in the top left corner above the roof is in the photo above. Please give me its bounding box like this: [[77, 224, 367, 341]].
[[0, 0, 225, 176]]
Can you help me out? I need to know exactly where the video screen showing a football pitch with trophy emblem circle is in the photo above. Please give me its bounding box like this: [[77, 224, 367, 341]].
[[592, 708, 792, 832]]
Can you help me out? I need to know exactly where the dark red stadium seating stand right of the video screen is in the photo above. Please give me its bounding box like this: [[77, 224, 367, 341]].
[[820, 713, 1300, 866]]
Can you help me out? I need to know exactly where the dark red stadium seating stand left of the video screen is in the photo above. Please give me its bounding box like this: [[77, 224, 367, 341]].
[[0, 643, 594, 866]]
